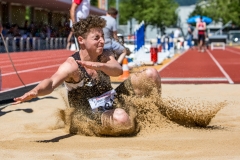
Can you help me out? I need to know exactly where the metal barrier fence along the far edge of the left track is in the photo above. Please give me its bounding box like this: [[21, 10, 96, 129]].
[[0, 37, 67, 53]]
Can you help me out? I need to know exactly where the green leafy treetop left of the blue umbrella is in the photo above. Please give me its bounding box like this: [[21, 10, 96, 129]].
[[119, 0, 178, 34]]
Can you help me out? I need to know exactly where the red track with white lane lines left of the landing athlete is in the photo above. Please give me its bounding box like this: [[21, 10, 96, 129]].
[[0, 50, 73, 91]]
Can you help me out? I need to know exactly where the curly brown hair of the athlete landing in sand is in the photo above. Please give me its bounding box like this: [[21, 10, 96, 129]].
[[73, 15, 106, 38]]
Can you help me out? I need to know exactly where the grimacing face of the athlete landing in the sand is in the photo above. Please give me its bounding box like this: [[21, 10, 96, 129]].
[[84, 28, 104, 55]]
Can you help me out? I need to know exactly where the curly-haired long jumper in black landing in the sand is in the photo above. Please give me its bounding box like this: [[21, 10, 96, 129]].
[[14, 15, 161, 135]]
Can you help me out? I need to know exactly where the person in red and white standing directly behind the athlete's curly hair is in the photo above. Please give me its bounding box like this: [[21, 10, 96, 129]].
[[70, 0, 90, 51]]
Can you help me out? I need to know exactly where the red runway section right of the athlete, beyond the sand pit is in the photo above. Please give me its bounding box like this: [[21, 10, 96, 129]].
[[159, 47, 240, 84]]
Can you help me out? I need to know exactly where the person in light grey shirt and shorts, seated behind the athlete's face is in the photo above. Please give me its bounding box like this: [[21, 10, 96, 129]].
[[102, 8, 127, 64]]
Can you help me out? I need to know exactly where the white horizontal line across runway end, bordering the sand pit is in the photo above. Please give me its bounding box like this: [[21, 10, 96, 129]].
[[161, 77, 228, 82]]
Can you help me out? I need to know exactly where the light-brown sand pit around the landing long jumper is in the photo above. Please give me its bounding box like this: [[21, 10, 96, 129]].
[[0, 84, 240, 160]]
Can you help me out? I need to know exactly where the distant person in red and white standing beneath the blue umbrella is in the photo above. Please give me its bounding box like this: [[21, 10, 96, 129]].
[[196, 16, 206, 52]]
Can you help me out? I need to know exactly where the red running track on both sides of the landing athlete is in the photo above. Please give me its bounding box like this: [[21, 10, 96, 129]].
[[0, 47, 240, 91]]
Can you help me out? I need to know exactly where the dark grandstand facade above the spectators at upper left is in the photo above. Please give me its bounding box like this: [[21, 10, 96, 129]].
[[0, 0, 106, 27]]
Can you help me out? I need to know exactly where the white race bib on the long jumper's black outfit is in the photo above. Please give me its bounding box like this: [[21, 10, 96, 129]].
[[88, 89, 116, 112]]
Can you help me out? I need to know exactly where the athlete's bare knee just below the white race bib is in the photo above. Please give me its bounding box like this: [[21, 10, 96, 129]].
[[113, 108, 130, 125]]
